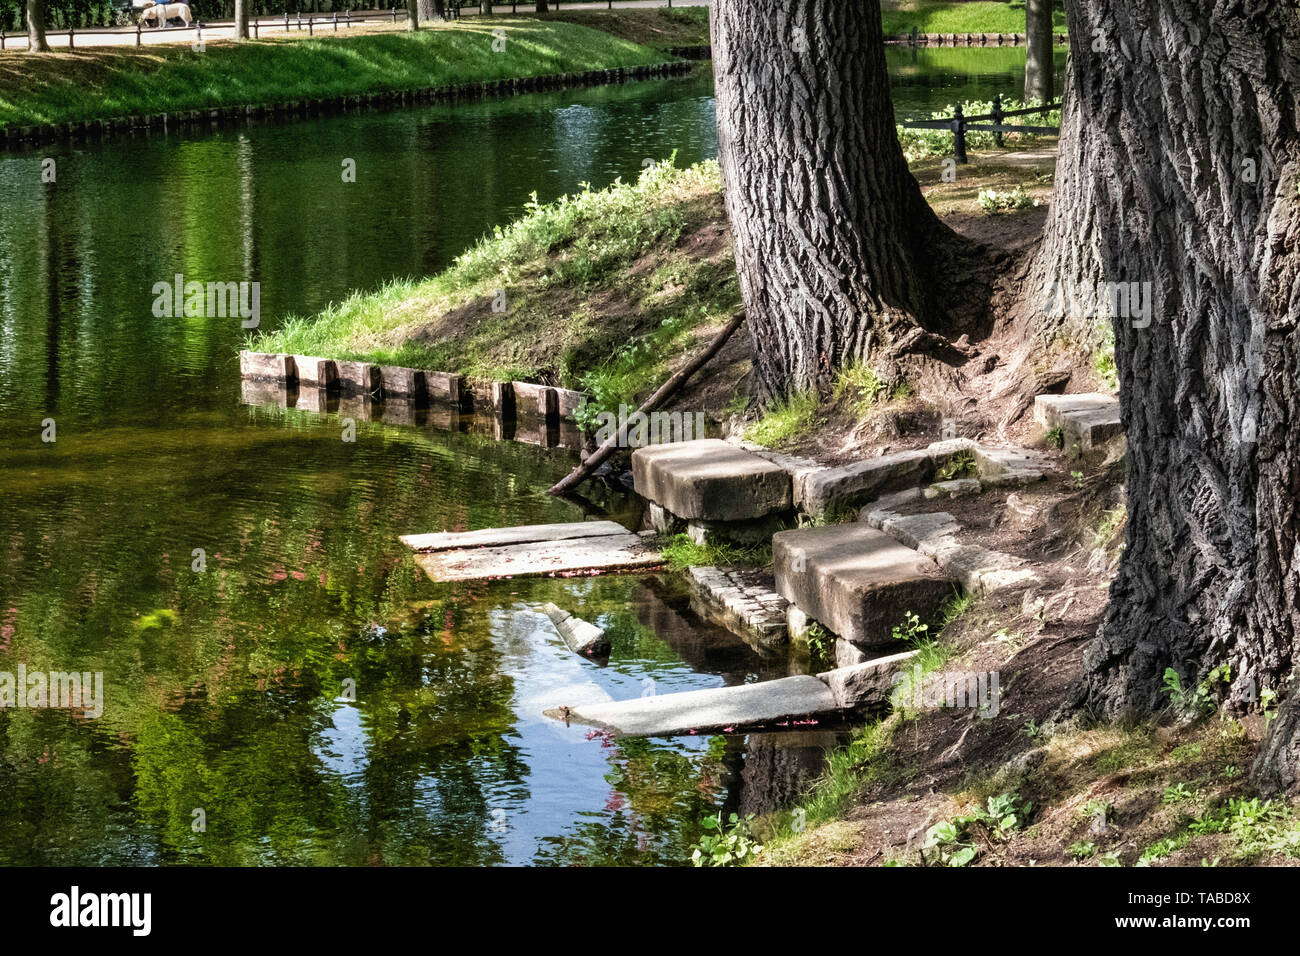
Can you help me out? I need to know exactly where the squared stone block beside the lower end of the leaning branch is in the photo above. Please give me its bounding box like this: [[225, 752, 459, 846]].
[[632, 438, 790, 522]]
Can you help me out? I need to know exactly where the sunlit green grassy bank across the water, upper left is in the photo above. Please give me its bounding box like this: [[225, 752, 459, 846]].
[[0, 17, 667, 127]]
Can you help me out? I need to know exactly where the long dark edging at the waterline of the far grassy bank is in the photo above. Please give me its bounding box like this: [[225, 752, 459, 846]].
[[0, 60, 692, 146]]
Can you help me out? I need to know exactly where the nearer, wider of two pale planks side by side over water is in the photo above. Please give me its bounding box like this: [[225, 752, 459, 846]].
[[415, 532, 663, 581]]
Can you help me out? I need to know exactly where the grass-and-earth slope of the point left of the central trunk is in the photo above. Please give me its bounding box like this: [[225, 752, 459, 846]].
[[248, 163, 740, 390]]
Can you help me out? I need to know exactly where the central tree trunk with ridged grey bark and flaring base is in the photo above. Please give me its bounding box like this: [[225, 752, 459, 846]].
[[710, 0, 988, 398]]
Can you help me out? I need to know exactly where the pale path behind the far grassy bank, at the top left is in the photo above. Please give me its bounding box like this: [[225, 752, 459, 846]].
[[4, 0, 709, 51]]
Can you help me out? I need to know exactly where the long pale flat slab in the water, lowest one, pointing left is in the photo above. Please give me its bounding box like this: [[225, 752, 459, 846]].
[[546, 675, 839, 737]]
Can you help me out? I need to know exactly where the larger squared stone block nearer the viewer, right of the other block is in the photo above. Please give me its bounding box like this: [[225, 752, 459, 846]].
[[772, 523, 958, 646]]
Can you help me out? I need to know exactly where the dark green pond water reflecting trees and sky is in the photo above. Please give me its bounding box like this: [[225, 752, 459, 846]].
[[0, 51, 1055, 865]]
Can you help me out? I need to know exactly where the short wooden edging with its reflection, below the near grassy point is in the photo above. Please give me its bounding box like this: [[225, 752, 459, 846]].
[[239, 351, 586, 447]]
